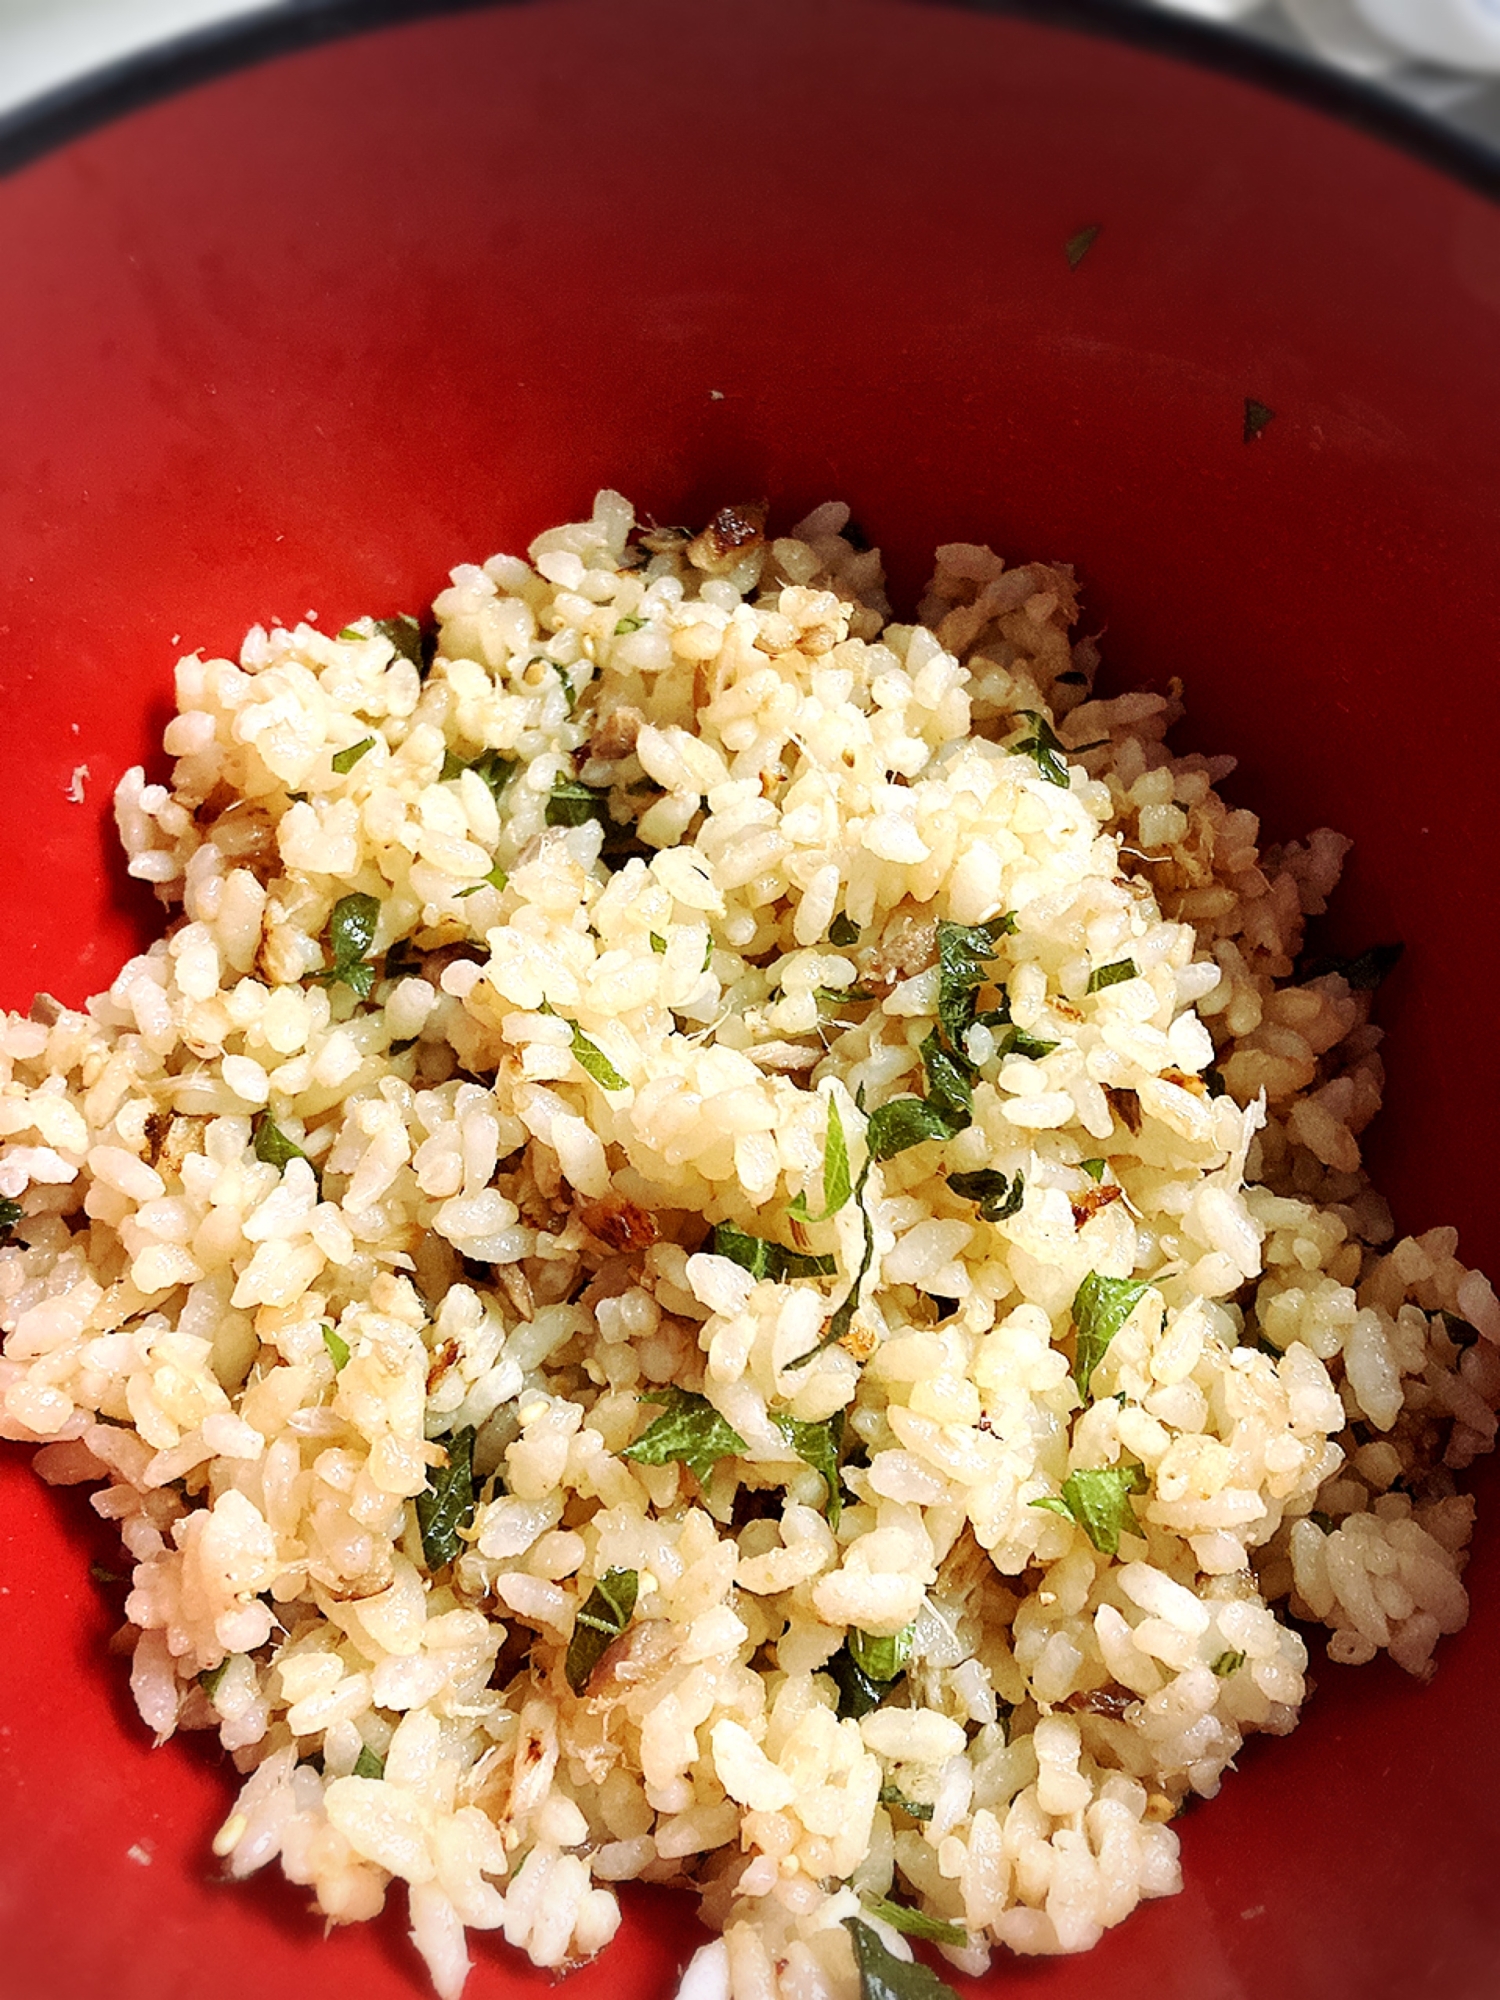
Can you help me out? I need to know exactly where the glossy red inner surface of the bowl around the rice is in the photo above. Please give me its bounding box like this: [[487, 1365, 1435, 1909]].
[[0, 0, 1500, 2000]]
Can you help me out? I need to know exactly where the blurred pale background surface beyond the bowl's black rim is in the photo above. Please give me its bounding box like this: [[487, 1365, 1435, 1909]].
[[0, 0, 1500, 144]]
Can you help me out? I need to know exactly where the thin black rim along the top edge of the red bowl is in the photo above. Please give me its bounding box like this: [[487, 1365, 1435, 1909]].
[[0, 0, 1500, 200]]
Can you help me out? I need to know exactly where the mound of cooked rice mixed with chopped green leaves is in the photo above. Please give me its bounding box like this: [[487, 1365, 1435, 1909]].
[[0, 492, 1500, 2000]]
